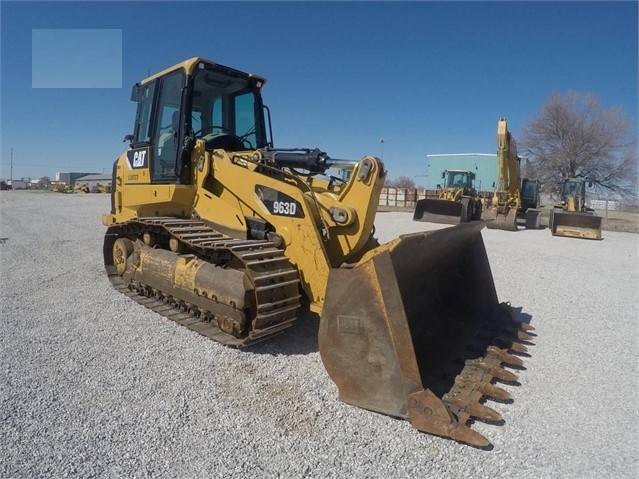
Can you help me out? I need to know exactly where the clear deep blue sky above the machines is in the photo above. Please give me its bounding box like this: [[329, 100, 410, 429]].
[[0, 1, 638, 185]]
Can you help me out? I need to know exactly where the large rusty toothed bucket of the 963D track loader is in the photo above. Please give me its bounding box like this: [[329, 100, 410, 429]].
[[319, 221, 533, 446]]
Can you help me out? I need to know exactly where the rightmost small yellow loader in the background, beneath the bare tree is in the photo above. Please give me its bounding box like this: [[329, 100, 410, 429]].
[[548, 178, 602, 240]]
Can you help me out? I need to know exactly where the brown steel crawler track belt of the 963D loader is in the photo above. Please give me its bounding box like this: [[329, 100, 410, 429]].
[[103, 217, 300, 348]]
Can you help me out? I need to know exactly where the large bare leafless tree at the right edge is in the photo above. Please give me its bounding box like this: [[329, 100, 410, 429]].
[[519, 92, 638, 200]]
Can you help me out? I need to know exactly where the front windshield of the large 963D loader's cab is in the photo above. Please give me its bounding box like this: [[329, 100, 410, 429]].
[[191, 68, 265, 151]]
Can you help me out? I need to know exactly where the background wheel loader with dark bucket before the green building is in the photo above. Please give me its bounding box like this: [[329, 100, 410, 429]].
[[413, 170, 482, 224]]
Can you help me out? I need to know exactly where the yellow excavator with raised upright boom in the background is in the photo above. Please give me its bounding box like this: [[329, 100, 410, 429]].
[[485, 118, 541, 231]]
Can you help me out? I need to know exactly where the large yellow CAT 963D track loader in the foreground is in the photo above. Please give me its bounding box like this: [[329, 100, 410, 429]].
[[103, 58, 531, 446]]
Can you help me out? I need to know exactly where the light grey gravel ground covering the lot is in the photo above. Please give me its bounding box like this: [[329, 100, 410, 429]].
[[0, 191, 639, 478]]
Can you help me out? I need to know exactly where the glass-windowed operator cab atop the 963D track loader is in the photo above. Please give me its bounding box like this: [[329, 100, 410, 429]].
[[126, 58, 268, 183]]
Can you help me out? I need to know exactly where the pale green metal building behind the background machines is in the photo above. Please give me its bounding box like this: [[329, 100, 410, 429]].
[[423, 153, 498, 192]]
